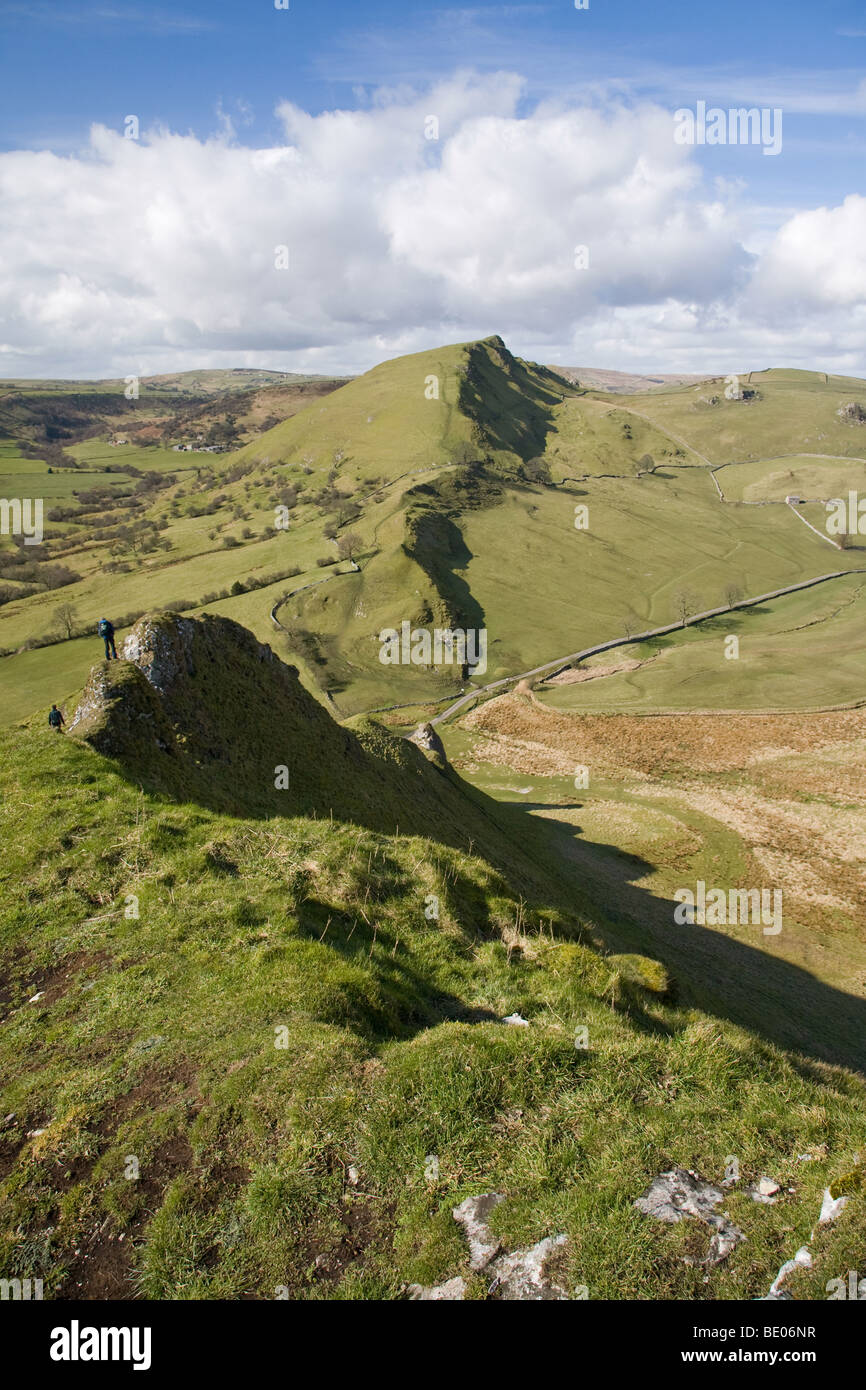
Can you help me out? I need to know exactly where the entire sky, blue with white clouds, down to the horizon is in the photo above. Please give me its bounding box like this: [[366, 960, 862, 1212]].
[[0, 0, 866, 379]]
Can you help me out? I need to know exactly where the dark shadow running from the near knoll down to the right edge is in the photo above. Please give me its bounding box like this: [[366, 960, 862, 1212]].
[[66, 611, 866, 1072]]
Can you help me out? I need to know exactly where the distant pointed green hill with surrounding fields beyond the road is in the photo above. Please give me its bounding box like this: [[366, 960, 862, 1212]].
[[0, 336, 866, 720]]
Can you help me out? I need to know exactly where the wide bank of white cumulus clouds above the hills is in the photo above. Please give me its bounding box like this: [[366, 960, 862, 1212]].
[[0, 74, 866, 377]]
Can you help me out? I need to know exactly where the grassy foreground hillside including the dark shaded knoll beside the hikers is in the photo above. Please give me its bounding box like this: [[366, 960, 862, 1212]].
[[0, 614, 866, 1300]]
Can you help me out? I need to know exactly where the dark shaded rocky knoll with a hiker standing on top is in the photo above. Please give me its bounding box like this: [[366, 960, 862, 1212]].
[[70, 613, 514, 845]]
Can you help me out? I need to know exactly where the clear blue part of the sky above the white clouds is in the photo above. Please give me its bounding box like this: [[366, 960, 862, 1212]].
[[0, 0, 866, 375]]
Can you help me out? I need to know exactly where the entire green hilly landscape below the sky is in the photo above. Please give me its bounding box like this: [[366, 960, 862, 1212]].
[[0, 336, 866, 1300]]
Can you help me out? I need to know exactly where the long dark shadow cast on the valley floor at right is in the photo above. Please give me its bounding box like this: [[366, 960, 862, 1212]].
[[518, 806, 866, 1073]]
